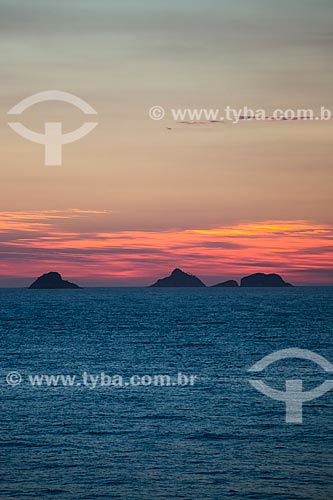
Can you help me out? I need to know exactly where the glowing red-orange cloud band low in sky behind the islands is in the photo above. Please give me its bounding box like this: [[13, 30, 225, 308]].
[[0, 209, 333, 286]]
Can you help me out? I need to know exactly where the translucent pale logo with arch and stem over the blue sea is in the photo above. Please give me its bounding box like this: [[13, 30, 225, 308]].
[[248, 349, 333, 424]]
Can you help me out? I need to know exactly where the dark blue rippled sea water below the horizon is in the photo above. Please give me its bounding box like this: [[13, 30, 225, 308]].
[[0, 288, 333, 500]]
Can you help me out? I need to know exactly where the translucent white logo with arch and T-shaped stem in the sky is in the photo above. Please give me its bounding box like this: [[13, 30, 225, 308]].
[[7, 90, 98, 166]]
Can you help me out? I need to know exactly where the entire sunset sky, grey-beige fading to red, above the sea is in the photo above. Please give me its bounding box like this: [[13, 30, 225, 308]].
[[0, 0, 333, 286]]
